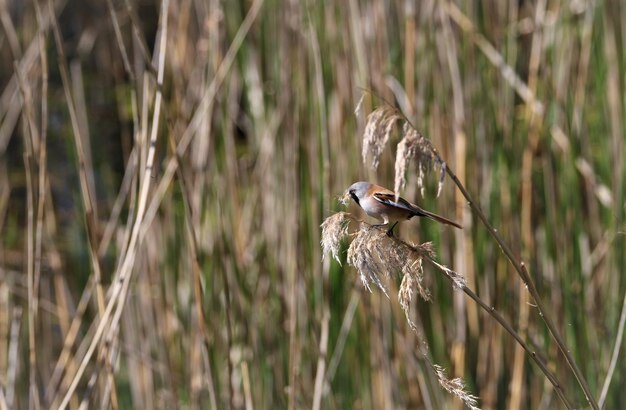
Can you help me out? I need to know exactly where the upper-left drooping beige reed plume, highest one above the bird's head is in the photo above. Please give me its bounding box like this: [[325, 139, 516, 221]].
[[362, 106, 402, 169]]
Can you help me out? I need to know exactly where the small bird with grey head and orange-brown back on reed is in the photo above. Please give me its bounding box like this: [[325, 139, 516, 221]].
[[346, 181, 463, 237]]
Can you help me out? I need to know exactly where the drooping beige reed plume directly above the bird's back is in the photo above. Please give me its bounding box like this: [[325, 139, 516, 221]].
[[394, 122, 446, 200]]
